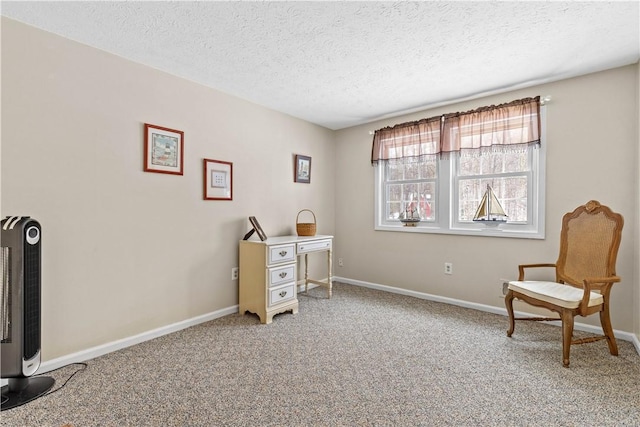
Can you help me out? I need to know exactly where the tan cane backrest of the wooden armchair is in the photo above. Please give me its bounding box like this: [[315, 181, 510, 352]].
[[556, 200, 624, 287]]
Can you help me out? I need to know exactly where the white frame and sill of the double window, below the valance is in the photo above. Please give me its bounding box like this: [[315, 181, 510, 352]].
[[374, 106, 547, 239]]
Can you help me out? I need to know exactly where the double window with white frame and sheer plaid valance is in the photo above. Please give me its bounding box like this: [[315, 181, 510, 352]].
[[372, 98, 545, 238]]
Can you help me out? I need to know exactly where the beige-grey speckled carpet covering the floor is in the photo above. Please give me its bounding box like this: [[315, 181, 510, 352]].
[[0, 283, 640, 427]]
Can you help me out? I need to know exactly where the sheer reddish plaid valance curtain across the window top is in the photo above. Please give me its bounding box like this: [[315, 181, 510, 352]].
[[371, 96, 540, 164]]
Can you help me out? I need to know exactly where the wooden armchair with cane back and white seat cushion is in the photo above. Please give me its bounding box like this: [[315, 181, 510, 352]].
[[505, 200, 624, 367]]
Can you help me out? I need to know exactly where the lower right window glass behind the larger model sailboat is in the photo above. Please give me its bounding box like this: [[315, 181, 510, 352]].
[[458, 176, 527, 222]]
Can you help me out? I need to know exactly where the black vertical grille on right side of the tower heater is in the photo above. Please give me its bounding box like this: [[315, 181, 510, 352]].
[[23, 242, 40, 360]]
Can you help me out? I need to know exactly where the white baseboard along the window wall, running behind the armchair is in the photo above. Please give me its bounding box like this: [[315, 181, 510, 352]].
[[333, 276, 640, 355]]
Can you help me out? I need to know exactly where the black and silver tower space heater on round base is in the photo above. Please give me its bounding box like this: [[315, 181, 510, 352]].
[[0, 216, 54, 411]]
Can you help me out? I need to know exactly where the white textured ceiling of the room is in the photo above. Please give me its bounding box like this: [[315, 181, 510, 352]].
[[1, 1, 640, 129]]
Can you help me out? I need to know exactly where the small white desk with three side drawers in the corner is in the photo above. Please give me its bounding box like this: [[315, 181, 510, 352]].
[[239, 236, 333, 323]]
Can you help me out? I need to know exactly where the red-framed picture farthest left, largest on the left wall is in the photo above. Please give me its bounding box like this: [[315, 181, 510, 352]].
[[144, 123, 184, 175]]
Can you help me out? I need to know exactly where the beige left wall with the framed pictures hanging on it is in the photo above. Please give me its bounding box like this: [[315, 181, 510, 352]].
[[1, 18, 335, 360]]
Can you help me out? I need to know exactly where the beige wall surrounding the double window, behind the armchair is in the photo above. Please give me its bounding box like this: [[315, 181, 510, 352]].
[[334, 65, 640, 332]]
